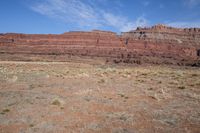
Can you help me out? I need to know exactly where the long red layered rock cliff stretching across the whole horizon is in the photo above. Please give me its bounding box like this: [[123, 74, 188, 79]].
[[0, 25, 200, 65]]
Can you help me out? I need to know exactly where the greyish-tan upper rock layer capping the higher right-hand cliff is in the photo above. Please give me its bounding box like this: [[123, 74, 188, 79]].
[[123, 25, 200, 46]]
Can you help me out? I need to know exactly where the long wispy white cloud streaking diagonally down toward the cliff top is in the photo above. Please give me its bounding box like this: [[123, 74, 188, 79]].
[[31, 0, 148, 31]]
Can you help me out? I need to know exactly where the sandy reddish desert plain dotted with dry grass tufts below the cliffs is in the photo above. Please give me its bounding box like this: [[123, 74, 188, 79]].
[[0, 61, 200, 133]]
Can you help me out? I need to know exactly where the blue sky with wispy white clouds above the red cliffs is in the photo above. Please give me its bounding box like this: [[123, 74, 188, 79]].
[[0, 0, 200, 34]]
